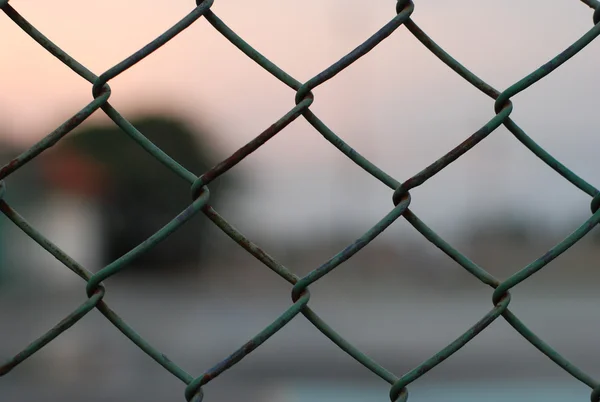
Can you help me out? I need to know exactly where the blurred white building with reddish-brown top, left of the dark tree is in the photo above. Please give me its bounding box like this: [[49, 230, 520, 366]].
[[0, 144, 106, 287]]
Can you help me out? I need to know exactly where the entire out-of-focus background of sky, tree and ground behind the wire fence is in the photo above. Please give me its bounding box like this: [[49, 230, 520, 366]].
[[0, 0, 600, 402]]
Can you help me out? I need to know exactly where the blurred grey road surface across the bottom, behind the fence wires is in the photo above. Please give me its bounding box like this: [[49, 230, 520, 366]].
[[0, 276, 600, 402]]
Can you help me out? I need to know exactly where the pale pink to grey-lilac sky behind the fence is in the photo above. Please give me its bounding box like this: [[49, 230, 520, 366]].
[[0, 0, 600, 242]]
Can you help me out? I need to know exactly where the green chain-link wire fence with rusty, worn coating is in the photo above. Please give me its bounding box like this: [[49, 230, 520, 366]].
[[0, 0, 600, 402]]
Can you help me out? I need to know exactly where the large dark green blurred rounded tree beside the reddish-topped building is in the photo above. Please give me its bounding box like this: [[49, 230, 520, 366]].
[[56, 116, 235, 272]]
